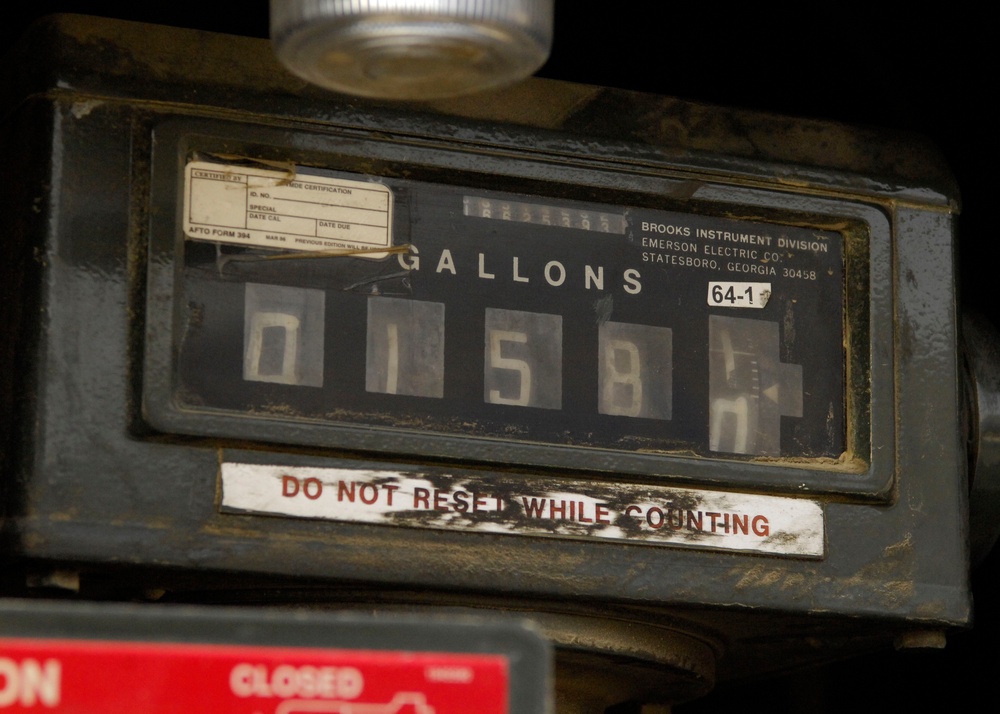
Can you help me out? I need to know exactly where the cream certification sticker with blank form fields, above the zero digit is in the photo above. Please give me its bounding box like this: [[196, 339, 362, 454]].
[[184, 161, 392, 251]]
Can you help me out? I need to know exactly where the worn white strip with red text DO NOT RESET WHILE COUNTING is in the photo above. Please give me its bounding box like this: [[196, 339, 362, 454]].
[[221, 462, 824, 557]]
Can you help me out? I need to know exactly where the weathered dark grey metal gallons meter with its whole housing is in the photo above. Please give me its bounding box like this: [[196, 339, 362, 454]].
[[2, 17, 984, 714]]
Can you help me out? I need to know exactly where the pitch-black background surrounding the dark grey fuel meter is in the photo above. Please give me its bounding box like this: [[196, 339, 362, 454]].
[[4, 0, 1000, 713]]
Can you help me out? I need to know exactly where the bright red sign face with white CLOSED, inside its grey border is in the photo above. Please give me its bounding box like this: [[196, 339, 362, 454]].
[[0, 638, 508, 714]]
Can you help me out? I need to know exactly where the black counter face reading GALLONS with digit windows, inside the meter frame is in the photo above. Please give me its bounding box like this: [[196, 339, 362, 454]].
[[151, 158, 846, 468]]
